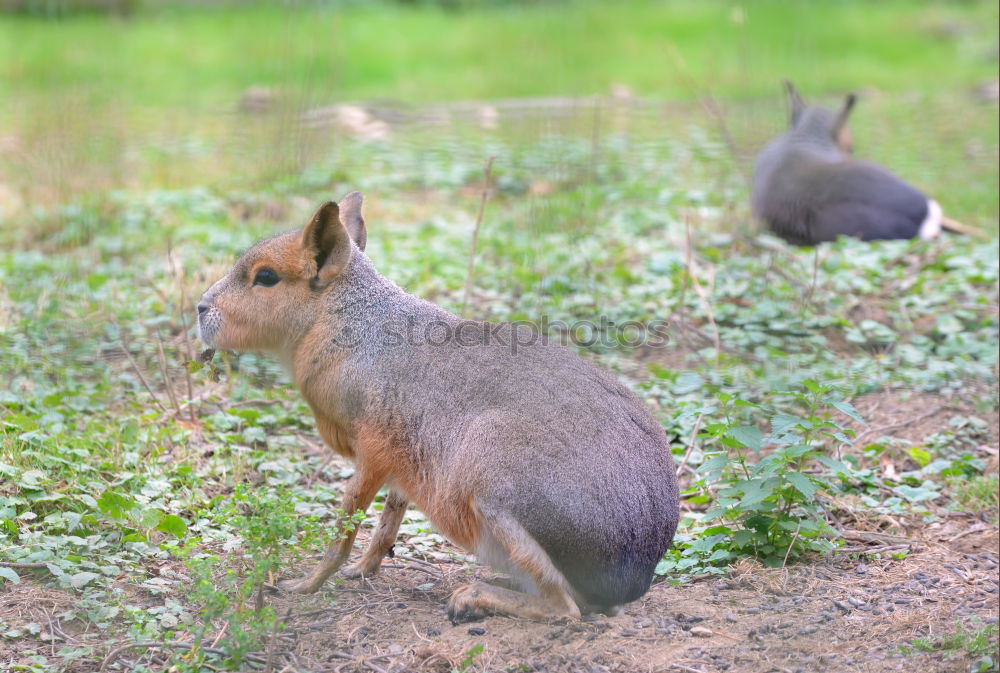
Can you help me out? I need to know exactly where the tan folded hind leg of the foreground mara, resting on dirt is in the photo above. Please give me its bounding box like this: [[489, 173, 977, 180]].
[[448, 512, 580, 623]]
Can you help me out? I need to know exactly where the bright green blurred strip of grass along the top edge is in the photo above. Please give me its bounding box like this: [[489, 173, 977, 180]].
[[0, 0, 998, 109]]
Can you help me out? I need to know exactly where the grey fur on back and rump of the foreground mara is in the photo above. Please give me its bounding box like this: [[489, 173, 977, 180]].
[[329, 254, 678, 607]]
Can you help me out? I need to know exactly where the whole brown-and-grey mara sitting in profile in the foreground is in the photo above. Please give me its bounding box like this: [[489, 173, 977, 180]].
[[198, 192, 678, 621]]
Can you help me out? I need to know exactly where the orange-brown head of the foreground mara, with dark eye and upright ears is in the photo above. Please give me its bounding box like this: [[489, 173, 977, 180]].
[[198, 192, 367, 352]]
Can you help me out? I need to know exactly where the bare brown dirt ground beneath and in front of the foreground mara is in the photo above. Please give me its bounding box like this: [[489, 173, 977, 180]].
[[0, 517, 1000, 673]]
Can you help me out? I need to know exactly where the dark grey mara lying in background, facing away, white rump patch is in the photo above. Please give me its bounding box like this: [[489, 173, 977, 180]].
[[753, 81, 971, 245]]
